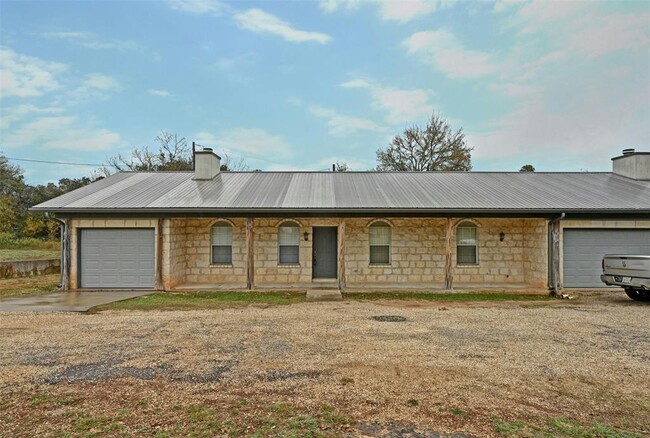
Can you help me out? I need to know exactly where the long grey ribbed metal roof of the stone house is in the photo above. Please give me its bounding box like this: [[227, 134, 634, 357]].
[[33, 172, 650, 214]]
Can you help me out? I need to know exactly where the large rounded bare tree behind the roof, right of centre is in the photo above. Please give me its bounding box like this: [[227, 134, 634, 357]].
[[377, 113, 472, 171]]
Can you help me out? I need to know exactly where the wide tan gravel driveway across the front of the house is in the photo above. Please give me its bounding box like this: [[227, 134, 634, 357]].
[[0, 292, 650, 436]]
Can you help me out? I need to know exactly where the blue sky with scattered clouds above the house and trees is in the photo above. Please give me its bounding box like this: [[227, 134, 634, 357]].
[[0, 0, 650, 184]]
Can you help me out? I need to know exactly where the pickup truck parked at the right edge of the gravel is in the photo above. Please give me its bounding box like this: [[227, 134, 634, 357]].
[[600, 254, 650, 301]]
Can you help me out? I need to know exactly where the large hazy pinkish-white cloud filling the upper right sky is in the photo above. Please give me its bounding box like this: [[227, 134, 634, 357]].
[[468, 1, 650, 169]]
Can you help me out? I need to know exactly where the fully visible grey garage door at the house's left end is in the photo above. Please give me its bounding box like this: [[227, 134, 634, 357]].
[[80, 228, 154, 289]]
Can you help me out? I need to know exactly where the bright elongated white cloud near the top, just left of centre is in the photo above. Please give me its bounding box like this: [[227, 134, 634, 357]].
[[235, 9, 332, 44]]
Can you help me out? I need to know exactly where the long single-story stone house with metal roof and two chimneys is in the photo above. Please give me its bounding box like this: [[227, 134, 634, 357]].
[[33, 148, 650, 290]]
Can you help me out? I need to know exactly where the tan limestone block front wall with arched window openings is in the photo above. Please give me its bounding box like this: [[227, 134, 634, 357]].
[[70, 217, 548, 290]]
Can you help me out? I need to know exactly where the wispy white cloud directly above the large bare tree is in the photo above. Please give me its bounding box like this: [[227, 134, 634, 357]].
[[341, 78, 433, 124]]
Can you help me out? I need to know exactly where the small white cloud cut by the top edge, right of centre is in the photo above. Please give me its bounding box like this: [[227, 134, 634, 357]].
[[319, 0, 456, 23]]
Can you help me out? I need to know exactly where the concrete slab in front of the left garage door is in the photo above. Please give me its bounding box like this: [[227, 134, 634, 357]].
[[0, 290, 155, 312]]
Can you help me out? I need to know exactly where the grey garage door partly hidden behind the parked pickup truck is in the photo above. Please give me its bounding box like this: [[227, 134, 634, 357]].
[[563, 229, 650, 287]]
